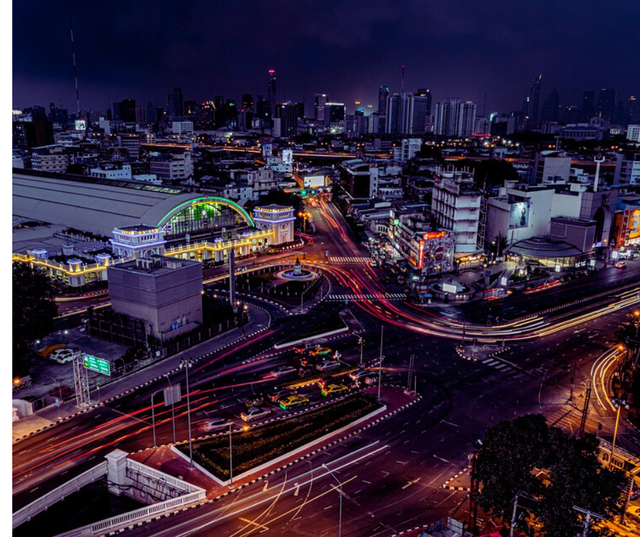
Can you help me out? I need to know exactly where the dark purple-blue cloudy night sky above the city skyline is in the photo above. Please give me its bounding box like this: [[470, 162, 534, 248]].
[[12, 0, 640, 115]]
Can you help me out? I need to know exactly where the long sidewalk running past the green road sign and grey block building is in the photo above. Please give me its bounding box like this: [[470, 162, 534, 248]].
[[12, 305, 270, 443]]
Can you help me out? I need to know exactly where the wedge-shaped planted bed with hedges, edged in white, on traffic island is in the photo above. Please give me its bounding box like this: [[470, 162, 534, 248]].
[[175, 394, 386, 484]]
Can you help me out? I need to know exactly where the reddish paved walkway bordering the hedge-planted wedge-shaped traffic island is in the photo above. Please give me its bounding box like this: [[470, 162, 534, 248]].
[[129, 386, 420, 500]]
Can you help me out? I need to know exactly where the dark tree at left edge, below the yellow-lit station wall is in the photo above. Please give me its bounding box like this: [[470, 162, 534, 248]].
[[12, 261, 58, 375]]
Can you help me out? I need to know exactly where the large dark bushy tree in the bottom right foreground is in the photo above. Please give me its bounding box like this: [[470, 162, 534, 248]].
[[474, 414, 625, 537]]
